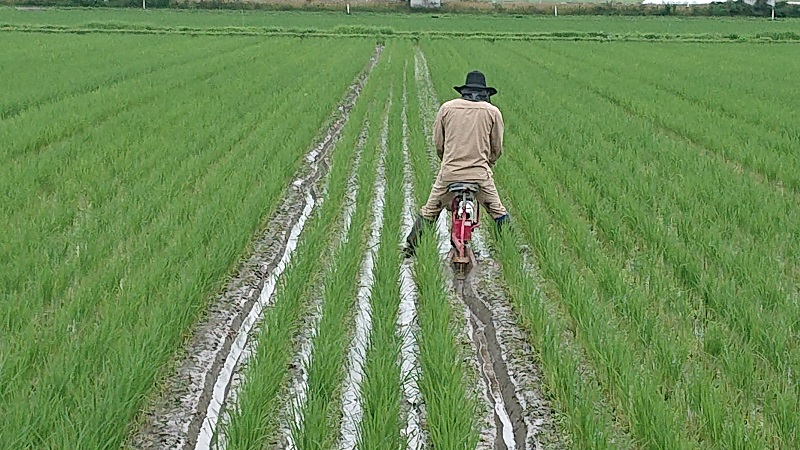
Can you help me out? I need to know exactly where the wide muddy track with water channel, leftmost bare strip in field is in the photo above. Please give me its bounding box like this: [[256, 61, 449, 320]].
[[129, 45, 383, 450]]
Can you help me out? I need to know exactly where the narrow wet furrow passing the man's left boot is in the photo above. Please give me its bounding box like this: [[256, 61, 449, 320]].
[[397, 81, 426, 450]]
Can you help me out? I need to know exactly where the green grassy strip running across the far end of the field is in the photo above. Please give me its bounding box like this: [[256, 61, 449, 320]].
[[0, 5, 800, 36]]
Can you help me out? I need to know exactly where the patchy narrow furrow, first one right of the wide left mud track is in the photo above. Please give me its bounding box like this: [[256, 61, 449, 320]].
[[280, 122, 369, 450]]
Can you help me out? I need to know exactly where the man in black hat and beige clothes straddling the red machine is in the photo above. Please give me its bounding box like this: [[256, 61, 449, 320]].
[[405, 71, 509, 256]]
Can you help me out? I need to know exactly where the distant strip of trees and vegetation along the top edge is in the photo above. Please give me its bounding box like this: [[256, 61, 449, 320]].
[[0, 0, 800, 18]]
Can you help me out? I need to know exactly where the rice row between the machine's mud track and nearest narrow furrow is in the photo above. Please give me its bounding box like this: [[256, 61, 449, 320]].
[[406, 43, 479, 448]]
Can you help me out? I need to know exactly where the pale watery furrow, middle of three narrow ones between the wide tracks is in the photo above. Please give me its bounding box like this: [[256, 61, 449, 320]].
[[339, 104, 391, 450]]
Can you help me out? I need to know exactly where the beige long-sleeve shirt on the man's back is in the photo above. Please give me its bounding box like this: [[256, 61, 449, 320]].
[[433, 98, 503, 182]]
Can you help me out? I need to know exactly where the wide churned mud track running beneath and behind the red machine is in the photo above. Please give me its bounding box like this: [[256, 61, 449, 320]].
[[415, 47, 561, 449]]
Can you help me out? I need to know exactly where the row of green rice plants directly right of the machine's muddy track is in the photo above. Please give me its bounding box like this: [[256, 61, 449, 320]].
[[423, 39, 630, 448]]
